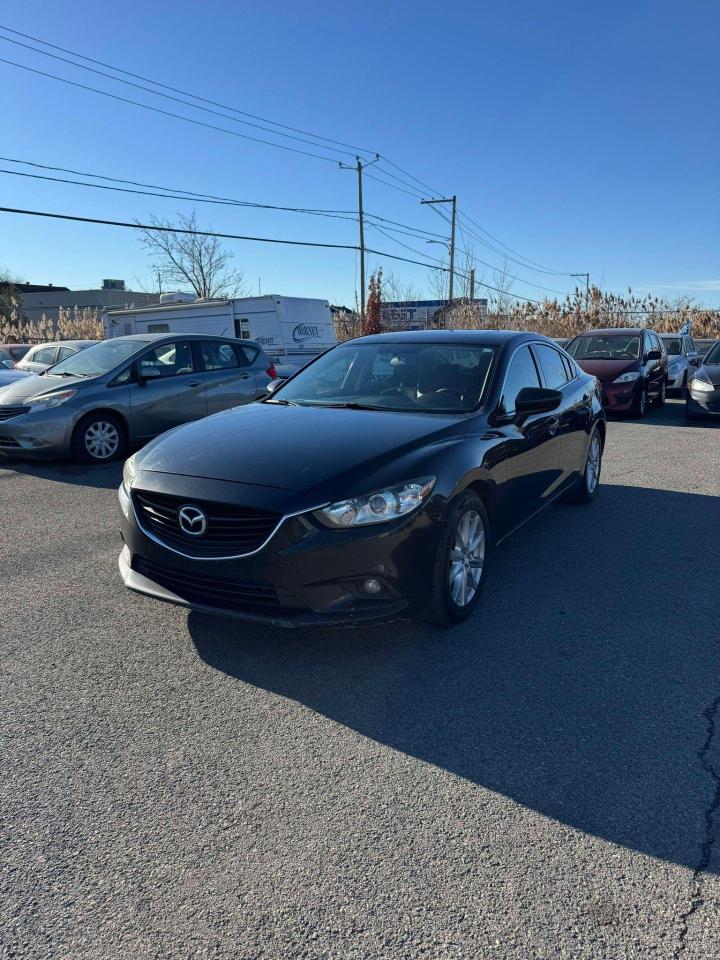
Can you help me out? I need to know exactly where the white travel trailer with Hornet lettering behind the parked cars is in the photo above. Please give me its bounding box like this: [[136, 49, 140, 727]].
[[102, 294, 337, 376]]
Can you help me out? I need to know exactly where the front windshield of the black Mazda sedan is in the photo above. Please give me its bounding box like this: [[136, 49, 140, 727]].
[[267, 341, 494, 413]]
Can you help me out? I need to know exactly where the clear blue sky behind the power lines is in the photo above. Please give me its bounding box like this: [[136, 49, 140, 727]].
[[0, 0, 720, 305]]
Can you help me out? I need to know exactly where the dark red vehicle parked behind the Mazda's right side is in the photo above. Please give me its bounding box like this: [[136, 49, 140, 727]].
[[565, 327, 668, 417]]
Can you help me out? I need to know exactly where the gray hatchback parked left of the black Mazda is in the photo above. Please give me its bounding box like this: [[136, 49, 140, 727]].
[[0, 333, 275, 463]]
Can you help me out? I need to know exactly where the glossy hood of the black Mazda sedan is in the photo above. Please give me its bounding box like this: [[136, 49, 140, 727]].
[[137, 403, 467, 496]]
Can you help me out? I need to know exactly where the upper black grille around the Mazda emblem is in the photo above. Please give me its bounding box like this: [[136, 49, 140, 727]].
[[133, 490, 281, 557]]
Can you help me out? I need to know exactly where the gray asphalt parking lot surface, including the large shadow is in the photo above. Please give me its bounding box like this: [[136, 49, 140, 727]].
[[0, 402, 720, 960]]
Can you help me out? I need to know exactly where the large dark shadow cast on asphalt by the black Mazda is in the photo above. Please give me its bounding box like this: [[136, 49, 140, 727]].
[[188, 485, 720, 868]]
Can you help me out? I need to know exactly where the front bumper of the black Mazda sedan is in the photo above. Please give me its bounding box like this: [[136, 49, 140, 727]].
[[119, 488, 441, 627]]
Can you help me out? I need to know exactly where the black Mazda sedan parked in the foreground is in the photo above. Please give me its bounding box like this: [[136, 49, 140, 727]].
[[119, 330, 605, 626]]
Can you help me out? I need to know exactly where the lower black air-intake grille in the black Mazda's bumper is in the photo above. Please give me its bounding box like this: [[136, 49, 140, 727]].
[[132, 555, 280, 612]]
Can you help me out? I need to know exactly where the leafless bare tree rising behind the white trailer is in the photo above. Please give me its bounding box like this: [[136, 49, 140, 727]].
[[140, 211, 249, 299]]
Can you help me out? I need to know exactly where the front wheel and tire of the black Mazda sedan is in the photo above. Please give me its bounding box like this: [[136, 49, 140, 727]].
[[423, 492, 490, 627]]
